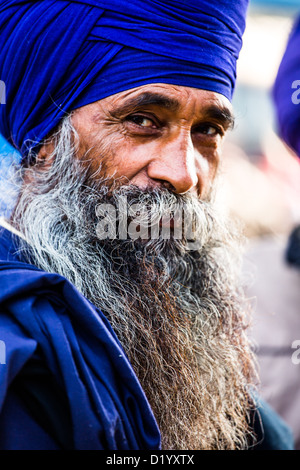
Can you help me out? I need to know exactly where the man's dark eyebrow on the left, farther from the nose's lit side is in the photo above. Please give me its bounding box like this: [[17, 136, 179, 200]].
[[110, 91, 180, 116]]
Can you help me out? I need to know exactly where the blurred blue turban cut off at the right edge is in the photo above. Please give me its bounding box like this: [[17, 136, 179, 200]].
[[273, 18, 300, 157]]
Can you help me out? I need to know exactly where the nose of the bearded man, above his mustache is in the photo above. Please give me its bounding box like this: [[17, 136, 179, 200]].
[[147, 130, 199, 194]]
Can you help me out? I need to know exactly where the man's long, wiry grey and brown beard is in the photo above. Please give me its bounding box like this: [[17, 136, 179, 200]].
[[12, 116, 255, 450]]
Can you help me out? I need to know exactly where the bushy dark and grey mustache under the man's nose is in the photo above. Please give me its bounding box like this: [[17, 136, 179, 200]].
[[86, 181, 215, 250]]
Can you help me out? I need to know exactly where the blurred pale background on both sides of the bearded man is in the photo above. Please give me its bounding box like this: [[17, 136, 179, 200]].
[[0, 0, 300, 449]]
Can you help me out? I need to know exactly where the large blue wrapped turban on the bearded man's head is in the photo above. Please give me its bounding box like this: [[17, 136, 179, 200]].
[[0, 0, 248, 161]]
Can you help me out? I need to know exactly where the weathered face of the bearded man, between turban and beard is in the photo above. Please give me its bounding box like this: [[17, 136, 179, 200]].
[[72, 84, 233, 198]]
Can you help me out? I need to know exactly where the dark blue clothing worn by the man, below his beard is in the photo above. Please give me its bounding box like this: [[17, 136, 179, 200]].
[[0, 228, 293, 450]]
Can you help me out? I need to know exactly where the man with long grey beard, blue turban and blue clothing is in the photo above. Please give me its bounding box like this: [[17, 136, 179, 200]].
[[0, 0, 290, 450]]
